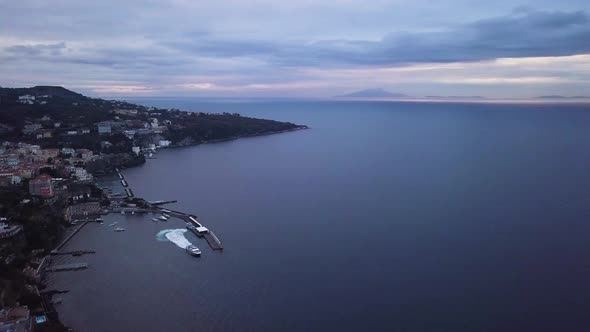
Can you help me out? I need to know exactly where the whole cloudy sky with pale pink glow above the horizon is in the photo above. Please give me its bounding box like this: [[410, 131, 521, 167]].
[[0, 0, 590, 98]]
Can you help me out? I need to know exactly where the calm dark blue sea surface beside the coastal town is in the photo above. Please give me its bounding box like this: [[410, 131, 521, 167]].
[[51, 99, 590, 332]]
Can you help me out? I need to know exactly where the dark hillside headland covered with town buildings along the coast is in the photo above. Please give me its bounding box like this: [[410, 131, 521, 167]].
[[0, 86, 306, 331]]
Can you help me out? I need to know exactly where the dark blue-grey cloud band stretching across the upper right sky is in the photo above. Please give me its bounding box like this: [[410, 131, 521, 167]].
[[164, 8, 590, 66]]
